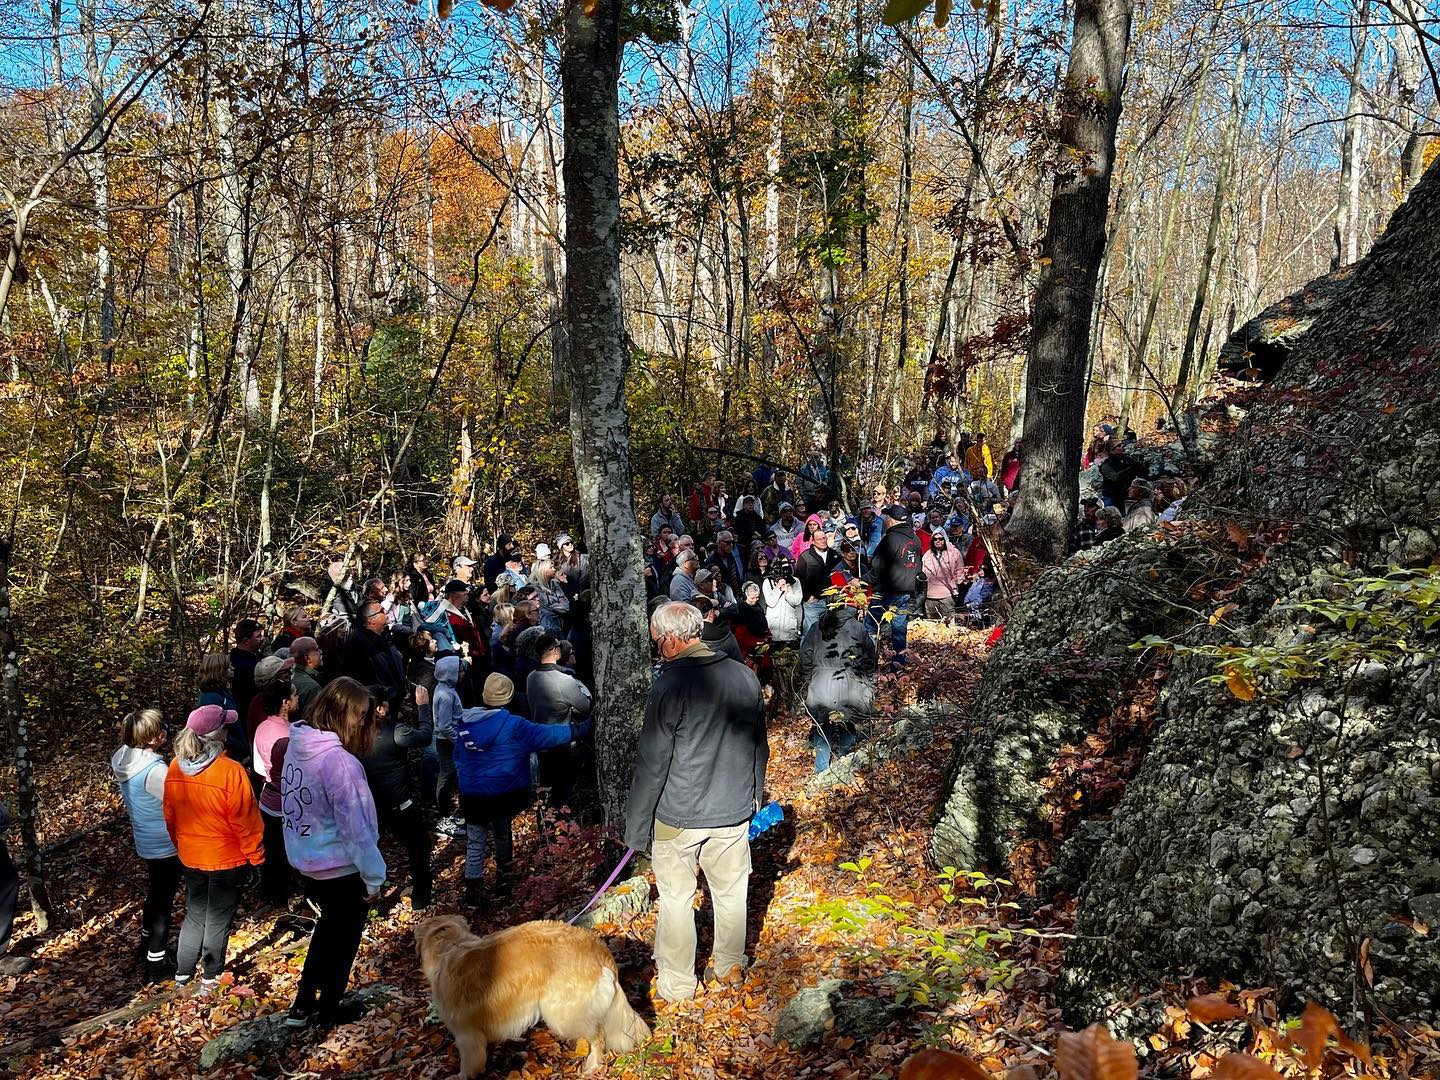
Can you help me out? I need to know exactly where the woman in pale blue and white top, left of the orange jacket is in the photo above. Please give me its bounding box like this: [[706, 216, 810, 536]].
[[109, 708, 180, 982]]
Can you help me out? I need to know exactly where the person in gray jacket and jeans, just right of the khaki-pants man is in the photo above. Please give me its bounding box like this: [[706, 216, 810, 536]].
[[801, 605, 876, 773]]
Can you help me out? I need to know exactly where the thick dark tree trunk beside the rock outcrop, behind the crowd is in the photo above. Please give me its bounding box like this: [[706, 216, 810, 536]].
[[1008, 0, 1133, 567]]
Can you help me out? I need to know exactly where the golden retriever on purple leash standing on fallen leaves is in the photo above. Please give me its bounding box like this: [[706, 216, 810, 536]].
[[415, 914, 649, 1080]]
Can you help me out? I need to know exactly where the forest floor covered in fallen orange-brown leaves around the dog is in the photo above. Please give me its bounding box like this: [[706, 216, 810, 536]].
[[0, 624, 1428, 1079]]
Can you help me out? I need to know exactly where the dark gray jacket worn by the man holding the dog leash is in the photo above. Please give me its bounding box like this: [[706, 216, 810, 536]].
[[625, 652, 770, 851]]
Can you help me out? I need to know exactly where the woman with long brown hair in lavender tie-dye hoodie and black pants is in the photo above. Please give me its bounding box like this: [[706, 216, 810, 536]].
[[281, 675, 384, 1027]]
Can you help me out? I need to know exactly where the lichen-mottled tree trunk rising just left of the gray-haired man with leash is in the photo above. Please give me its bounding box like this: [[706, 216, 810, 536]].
[[560, 0, 649, 819]]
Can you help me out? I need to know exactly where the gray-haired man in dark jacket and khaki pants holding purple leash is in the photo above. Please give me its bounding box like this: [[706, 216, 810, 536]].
[[625, 603, 770, 1001]]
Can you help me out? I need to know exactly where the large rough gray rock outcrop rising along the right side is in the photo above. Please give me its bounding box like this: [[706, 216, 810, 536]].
[[933, 156, 1440, 1025]]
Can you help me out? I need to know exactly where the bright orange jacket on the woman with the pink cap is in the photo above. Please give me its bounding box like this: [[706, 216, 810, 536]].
[[161, 753, 265, 870]]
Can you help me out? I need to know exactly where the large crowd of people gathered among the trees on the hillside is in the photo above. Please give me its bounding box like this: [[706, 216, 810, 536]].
[[0, 426, 1184, 1027]]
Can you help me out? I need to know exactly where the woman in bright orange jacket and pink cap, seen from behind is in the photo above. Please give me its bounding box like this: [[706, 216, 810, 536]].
[[161, 706, 265, 994]]
